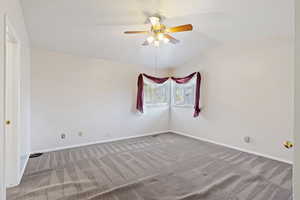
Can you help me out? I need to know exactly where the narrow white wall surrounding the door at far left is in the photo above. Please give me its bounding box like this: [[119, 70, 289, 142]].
[[0, 0, 30, 199]]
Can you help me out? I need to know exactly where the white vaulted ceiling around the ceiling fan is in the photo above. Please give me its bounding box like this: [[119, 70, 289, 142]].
[[22, 0, 294, 67]]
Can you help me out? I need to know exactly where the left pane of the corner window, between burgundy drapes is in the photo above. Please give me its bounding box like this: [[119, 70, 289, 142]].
[[144, 81, 170, 106]]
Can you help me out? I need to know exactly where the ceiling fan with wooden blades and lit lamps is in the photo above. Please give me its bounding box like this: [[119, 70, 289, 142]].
[[124, 16, 193, 47]]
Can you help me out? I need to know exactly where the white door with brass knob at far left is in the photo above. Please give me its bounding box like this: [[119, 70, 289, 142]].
[[5, 19, 20, 187]]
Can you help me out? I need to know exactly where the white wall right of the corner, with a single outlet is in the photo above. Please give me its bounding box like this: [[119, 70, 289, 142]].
[[171, 37, 294, 161]]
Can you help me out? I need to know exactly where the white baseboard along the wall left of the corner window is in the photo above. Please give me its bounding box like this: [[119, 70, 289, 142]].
[[31, 130, 169, 154]]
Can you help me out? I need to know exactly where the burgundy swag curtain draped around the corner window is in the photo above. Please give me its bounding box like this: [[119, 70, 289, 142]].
[[136, 72, 201, 117]]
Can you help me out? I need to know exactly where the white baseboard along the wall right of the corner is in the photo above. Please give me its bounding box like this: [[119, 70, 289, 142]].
[[169, 130, 293, 165]]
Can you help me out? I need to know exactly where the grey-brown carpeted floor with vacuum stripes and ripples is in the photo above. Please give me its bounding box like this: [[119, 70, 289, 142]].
[[8, 133, 292, 200]]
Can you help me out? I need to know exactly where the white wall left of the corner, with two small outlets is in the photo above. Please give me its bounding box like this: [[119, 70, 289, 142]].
[[31, 49, 169, 152]]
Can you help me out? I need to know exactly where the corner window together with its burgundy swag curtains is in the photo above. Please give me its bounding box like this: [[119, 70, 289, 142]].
[[136, 72, 201, 117]]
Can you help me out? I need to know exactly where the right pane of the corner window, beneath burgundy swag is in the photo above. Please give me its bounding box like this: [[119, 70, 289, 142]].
[[172, 79, 196, 107]]
